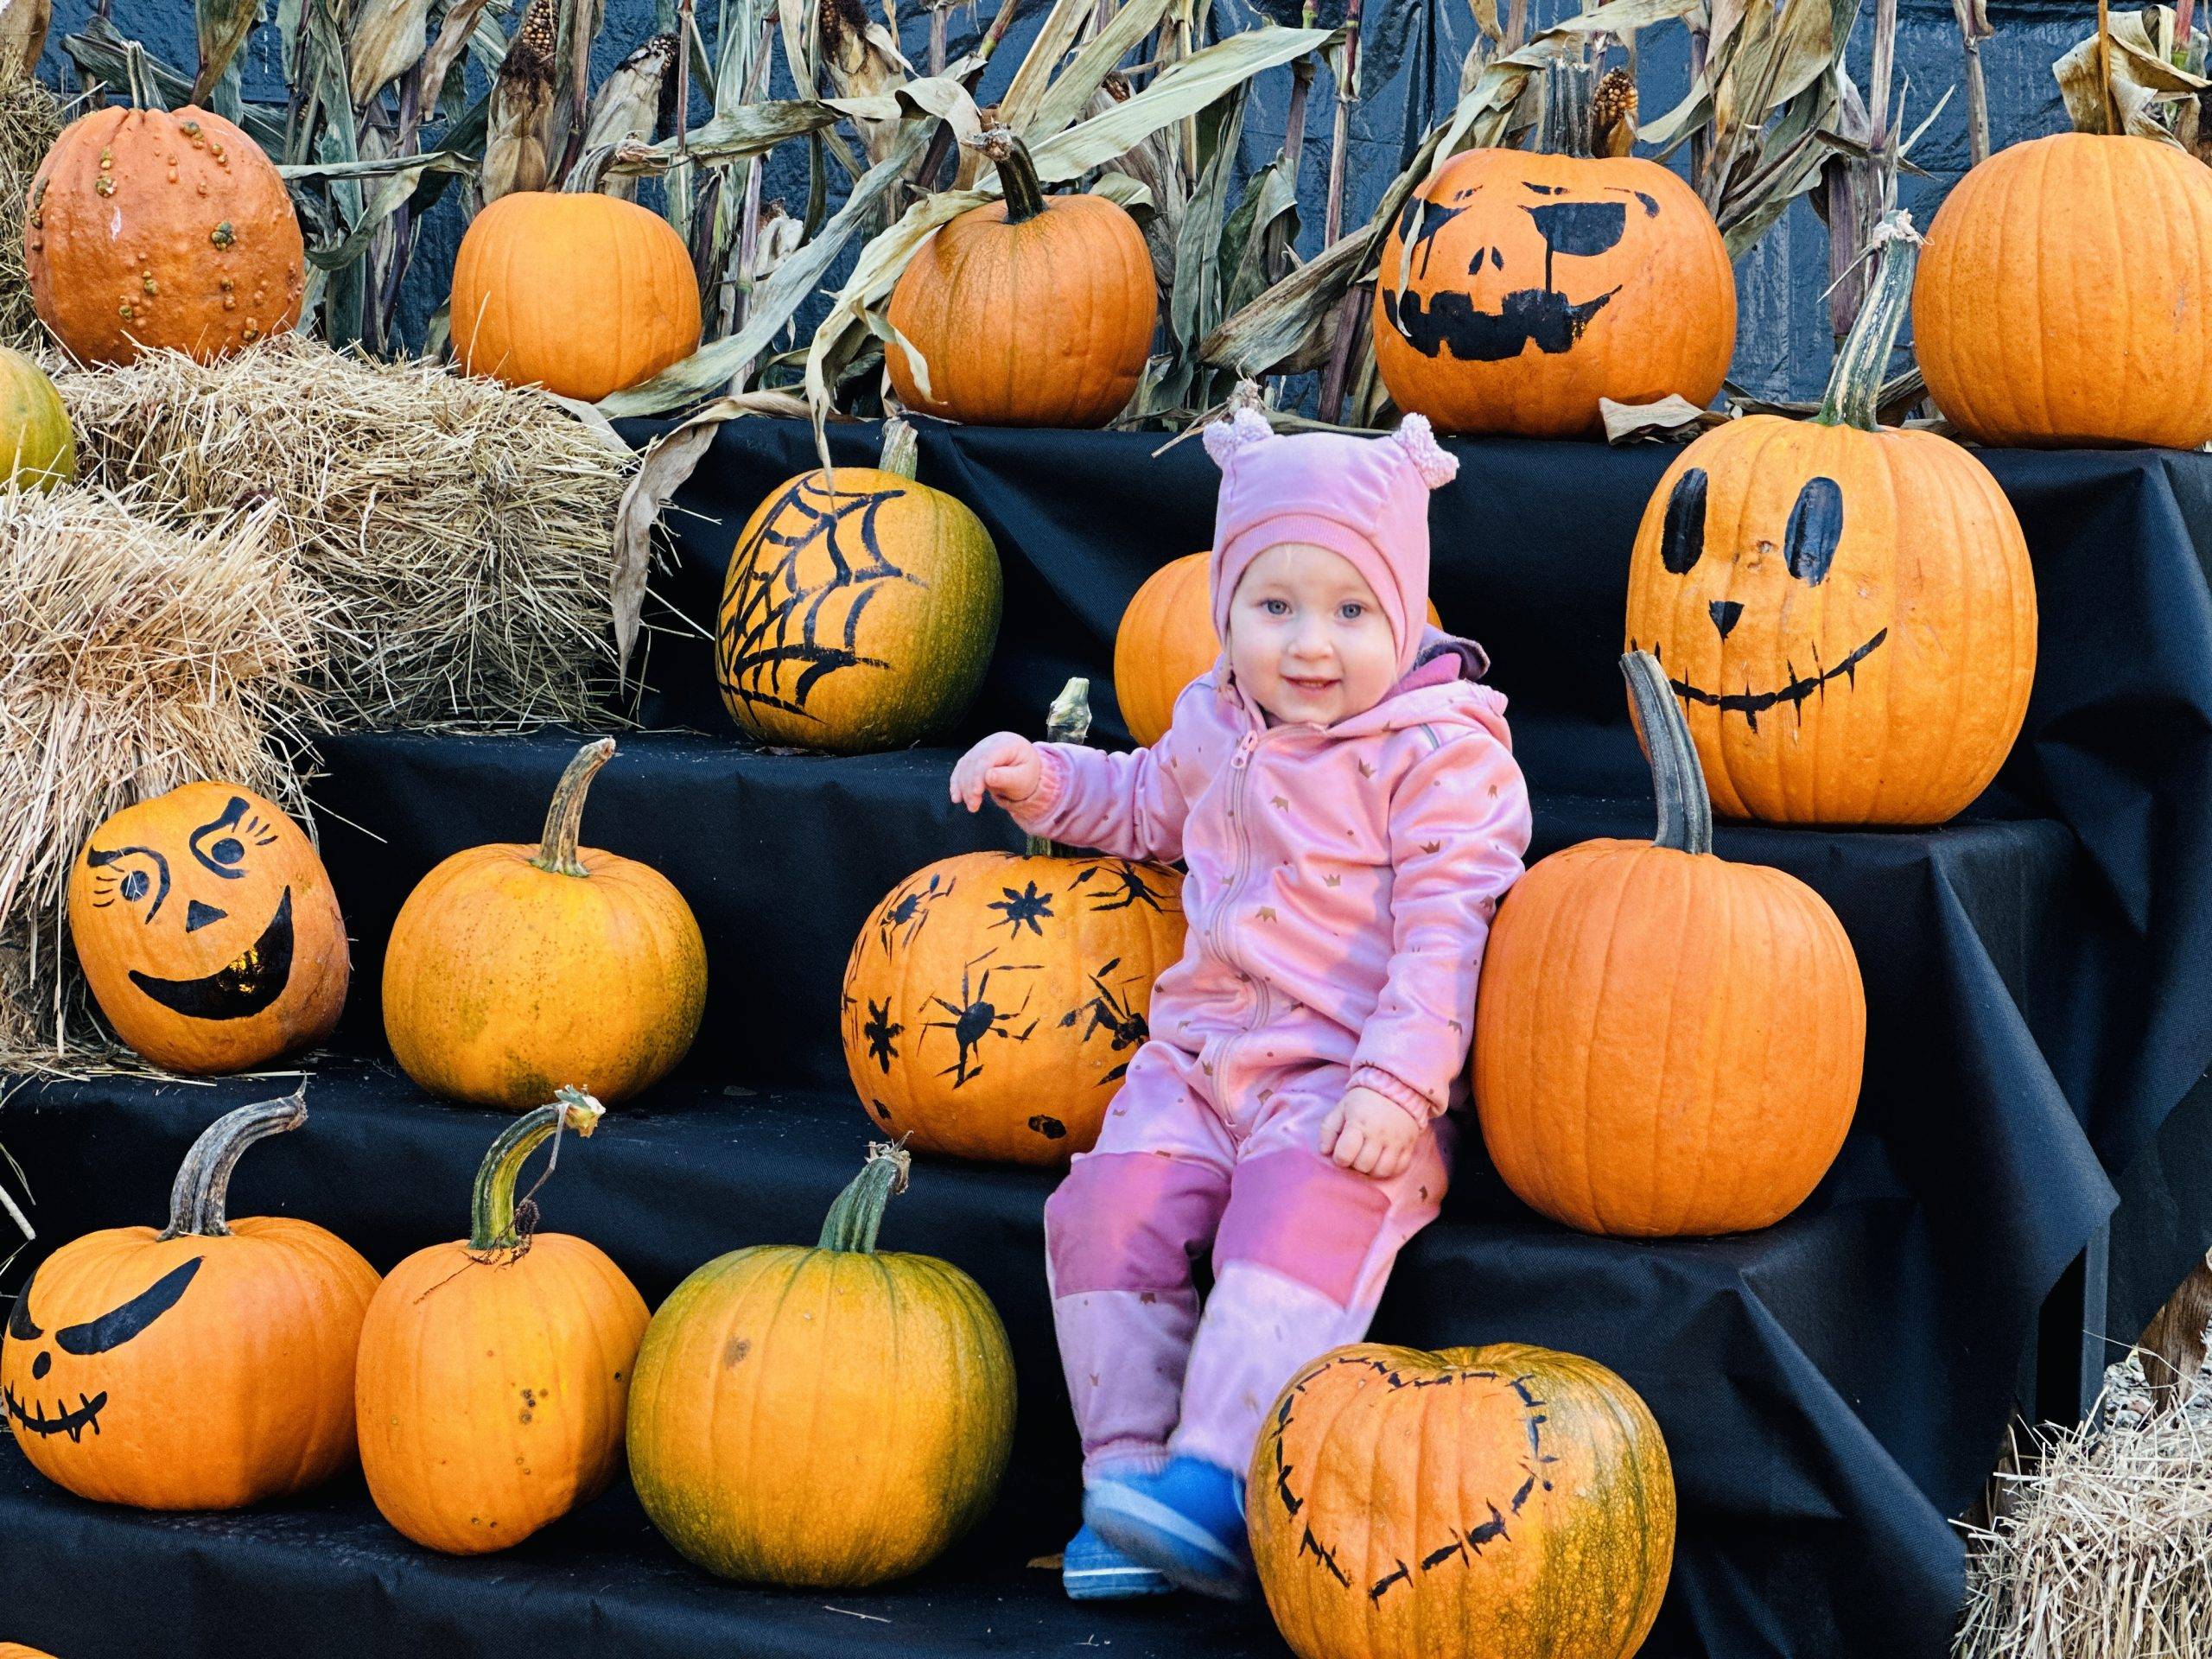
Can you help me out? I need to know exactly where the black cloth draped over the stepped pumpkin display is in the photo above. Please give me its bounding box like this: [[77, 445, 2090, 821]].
[[0, 420, 2212, 1659]]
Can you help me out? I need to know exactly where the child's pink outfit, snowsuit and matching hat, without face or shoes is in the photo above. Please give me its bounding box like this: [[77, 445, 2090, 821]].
[[1008, 416, 1529, 1480]]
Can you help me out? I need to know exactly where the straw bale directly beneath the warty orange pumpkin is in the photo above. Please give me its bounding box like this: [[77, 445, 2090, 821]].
[[58, 336, 635, 730]]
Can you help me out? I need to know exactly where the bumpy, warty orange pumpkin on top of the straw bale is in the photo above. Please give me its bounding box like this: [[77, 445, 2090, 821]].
[[24, 106, 308, 363]]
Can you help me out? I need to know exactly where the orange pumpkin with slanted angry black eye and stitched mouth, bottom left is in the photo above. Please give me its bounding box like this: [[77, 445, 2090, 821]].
[[0, 1095, 376, 1509]]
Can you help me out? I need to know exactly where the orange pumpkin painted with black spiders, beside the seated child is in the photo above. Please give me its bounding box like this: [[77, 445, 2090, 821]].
[[841, 679, 1184, 1164]]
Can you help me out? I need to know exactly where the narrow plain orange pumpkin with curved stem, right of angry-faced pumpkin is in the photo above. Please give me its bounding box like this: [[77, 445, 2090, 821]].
[[354, 1089, 646, 1555]]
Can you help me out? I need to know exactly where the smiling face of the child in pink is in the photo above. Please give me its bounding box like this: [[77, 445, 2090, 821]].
[[1228, 542, 1398, 726]]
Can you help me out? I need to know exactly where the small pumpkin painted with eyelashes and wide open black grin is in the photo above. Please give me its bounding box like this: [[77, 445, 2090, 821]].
[[68, 783, 352, 1073]]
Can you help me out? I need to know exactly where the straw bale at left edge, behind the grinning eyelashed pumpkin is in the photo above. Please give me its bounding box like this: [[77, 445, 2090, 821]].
[[0, 489, 323, 1068]]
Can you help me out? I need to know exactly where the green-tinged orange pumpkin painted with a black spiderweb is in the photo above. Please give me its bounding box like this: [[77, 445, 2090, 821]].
[[715, 420, 1000, 754]]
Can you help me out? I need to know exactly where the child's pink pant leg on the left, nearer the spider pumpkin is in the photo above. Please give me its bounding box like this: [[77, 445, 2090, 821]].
[[1044, 1042, 1232, 1482]]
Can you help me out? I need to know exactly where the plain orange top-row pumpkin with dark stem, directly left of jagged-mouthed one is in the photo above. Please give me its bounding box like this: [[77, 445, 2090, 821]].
[[882, 128, 1159, 427]]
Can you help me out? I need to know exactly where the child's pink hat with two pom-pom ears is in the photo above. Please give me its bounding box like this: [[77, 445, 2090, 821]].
[[1205, 410, 1460, 675]]
